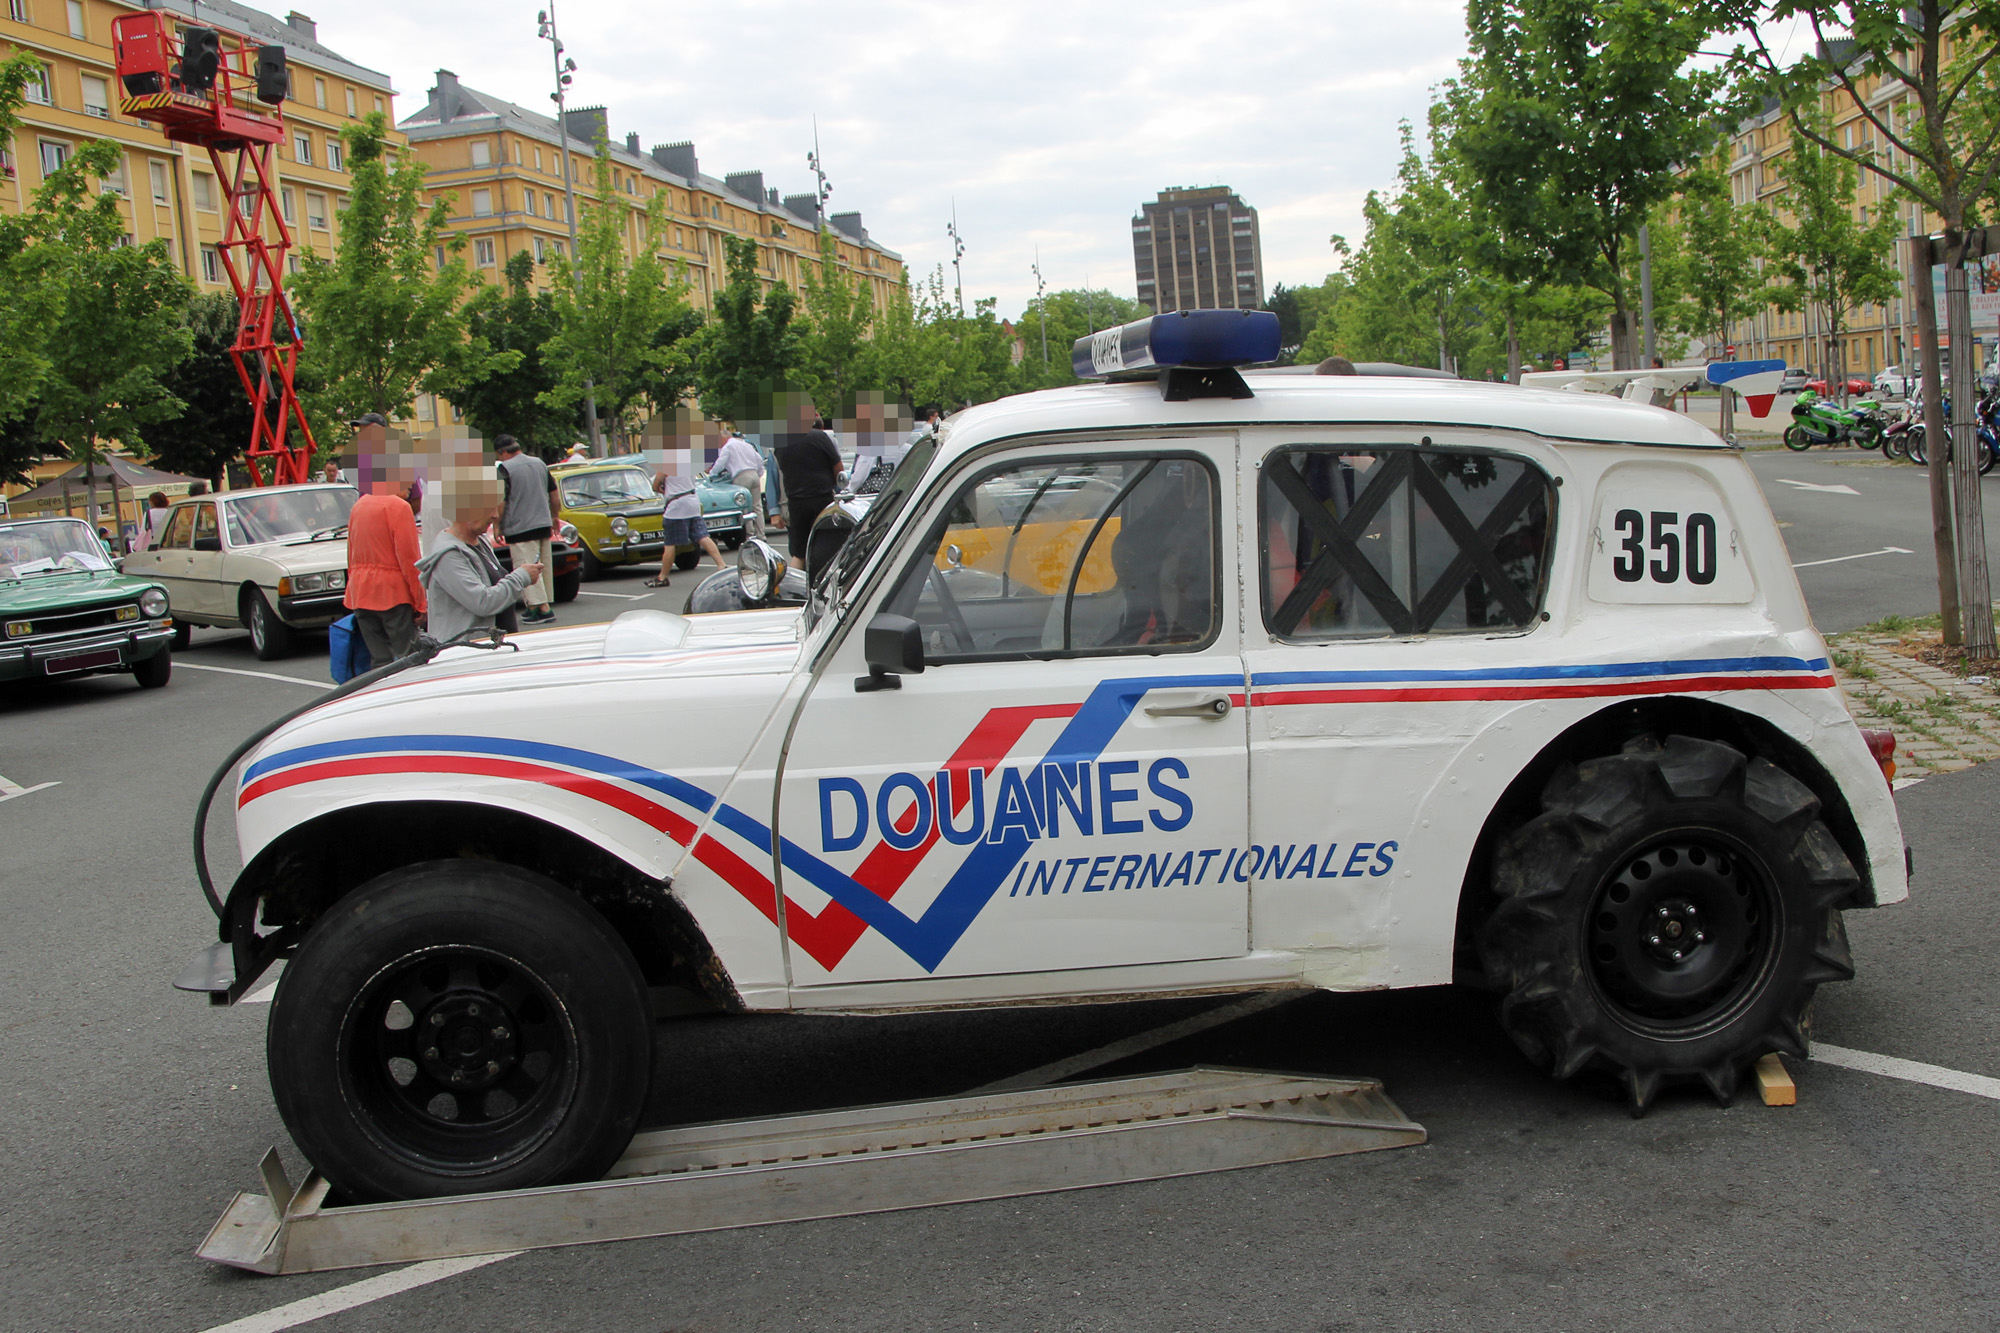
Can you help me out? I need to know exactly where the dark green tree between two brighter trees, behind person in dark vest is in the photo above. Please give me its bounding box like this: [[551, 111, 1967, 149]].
[[450, 250, 584, 454]]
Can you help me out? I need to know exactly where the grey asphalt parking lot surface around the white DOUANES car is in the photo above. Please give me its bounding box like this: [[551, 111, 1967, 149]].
[[0, 490, 2000, 1333]]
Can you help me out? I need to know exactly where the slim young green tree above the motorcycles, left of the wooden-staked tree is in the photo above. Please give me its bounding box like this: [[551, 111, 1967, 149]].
[[1764, 132, 1902, 396]]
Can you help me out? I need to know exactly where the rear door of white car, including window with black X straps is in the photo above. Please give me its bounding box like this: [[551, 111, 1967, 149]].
[[1244, 428, 1574, 985]]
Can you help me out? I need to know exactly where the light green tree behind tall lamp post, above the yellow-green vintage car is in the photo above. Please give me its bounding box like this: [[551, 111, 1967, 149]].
[[540, 140, 704, 440]]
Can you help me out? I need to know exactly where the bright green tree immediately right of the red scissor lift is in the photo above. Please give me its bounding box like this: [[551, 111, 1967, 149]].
[[292, 112, 500, 448]]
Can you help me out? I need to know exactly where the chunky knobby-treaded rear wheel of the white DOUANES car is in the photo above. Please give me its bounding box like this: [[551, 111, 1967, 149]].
[[1480, 737, 1860, 1115]]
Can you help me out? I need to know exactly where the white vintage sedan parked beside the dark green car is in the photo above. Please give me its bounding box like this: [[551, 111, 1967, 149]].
[[122, 484, 360, 660]]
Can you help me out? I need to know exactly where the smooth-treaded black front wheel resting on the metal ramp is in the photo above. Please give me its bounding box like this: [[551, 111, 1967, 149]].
[[266, 861, 652, 1199]]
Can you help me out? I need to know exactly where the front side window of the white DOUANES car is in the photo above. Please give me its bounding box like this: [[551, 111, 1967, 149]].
[[886, 454, 1220, 662]]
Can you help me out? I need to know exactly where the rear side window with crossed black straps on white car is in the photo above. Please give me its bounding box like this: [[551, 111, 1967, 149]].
[[1260, 444, 1556, 642]]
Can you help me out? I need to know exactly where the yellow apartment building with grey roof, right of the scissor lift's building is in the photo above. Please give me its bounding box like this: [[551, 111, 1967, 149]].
[[400, 70, 904, 320]]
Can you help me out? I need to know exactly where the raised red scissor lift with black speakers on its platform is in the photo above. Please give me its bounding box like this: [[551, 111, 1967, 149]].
[[112, 10, 314, 486]]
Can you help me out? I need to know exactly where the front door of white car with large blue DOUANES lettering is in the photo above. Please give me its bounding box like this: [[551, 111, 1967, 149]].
[[780, 434, 1248, 987]]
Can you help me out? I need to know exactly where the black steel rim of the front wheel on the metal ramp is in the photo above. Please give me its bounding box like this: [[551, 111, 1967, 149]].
[[340, 945, 576, 1173]]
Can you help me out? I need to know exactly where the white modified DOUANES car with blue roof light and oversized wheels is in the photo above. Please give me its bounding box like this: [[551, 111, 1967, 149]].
[[190, 312, 1906, 1199]]
